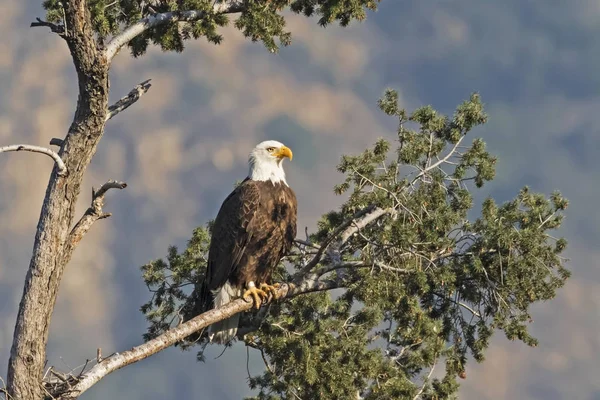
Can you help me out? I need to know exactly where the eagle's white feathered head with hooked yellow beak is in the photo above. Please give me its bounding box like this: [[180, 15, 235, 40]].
[[248, 140, 292, 186]]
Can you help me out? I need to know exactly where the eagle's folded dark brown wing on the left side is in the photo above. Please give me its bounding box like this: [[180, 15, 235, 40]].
[[205, 180, 259, 290]]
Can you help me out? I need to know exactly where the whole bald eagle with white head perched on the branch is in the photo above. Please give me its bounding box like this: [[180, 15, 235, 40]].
[[201, 140, 297, 344]]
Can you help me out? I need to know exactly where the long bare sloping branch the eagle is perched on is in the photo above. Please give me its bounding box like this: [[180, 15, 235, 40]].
[[53, 278, 339, 400]]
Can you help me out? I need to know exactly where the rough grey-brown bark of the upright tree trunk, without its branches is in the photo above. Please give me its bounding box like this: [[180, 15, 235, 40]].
[[8, 0, 109, 400]]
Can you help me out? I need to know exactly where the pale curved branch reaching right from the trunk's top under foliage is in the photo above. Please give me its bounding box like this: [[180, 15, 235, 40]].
[[105, 0, 244, 62]]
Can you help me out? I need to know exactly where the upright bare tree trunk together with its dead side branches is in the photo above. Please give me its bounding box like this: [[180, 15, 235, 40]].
[[0, 0, 243, 400]]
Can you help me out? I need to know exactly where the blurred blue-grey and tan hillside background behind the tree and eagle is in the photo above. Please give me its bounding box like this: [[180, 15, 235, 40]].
[[0, 0, 600, 400]]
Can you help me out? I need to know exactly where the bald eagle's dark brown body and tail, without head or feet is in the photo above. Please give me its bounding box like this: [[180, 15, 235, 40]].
[[202, 178, 297, 343]]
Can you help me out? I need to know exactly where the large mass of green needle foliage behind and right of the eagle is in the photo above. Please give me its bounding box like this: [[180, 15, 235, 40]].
[[143, 91, 569, 400]]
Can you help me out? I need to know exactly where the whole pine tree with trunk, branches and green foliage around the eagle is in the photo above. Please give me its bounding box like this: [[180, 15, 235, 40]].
[[0, 0, 569, 400]]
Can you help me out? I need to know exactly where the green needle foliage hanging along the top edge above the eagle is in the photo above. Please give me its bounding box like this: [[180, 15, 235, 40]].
[[43, 0, 380, 57]]
